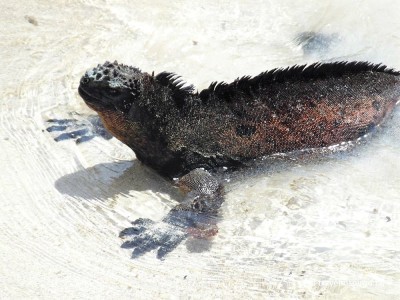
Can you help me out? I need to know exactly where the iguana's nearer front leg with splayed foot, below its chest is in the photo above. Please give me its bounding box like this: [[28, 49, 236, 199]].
[[120, 169, 224, 259]]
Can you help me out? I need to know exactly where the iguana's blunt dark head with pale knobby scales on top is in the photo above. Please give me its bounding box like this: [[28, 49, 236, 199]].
[[78, 61, 143, 113]]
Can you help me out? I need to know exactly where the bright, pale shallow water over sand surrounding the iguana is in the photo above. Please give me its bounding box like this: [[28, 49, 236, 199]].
[[0, 0, 400, 299]]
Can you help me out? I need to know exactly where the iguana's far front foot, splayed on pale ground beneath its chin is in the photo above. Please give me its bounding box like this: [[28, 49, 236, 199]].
[[46, 116, 112, 144]]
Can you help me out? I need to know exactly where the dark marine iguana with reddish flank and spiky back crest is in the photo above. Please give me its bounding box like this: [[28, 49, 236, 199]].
[[79, 62, 400, 258]]
